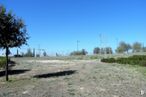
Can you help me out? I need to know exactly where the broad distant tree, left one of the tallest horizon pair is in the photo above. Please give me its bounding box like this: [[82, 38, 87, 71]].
[[116, 41, 132, 53]]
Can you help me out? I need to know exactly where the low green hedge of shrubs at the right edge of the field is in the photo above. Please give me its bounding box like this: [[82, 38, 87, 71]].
[[101, 55, 146, 66]]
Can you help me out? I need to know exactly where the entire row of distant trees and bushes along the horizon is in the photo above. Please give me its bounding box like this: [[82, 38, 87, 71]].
[[22, 41, 146, 57]]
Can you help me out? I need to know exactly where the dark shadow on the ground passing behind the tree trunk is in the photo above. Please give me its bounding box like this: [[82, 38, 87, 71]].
[[0, 69, 30, 77]]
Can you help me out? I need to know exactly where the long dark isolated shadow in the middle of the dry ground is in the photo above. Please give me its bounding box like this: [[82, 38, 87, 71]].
[[34, 70, 76, 78]]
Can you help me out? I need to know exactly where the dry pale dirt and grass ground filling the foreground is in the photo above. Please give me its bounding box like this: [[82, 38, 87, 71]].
[[0, 58, 146, 97]]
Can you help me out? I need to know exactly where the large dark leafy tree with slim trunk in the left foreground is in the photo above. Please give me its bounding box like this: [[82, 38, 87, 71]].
[[0, 6, 28, 81]]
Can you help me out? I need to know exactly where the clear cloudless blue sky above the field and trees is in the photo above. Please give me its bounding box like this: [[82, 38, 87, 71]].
[[0, 0, 146, 55]]
